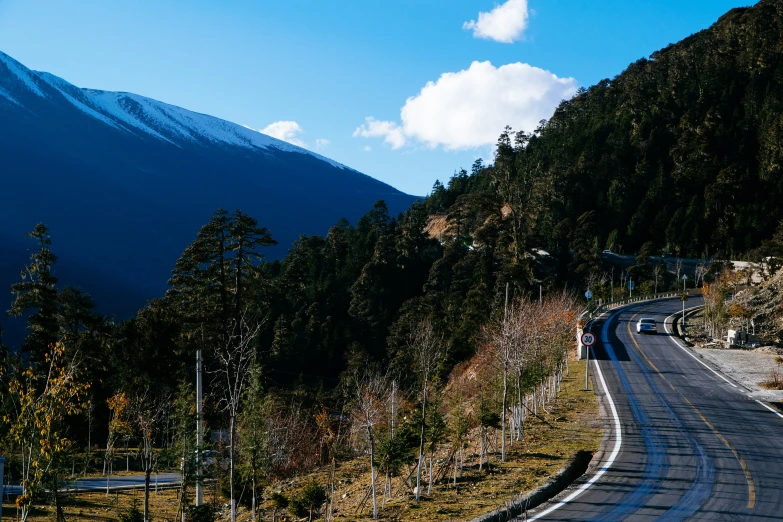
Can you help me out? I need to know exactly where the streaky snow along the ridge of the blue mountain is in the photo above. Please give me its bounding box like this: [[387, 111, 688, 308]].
[[0, 51, 348, 169]]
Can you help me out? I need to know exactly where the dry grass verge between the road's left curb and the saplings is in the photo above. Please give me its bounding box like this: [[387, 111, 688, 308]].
[[262, 363, 602, 521]]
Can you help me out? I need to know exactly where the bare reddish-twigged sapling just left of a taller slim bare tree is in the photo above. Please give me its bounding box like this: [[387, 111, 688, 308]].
[[351, 373, 389, 518]]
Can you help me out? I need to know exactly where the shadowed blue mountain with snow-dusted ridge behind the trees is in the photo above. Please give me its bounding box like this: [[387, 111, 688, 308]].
[[0, 47, 415, 342]]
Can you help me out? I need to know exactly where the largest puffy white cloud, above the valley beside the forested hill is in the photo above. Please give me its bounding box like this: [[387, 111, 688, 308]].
[[353, 62, 577, 150]]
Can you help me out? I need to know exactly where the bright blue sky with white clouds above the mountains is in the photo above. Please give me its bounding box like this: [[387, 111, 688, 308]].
[[0, 0, 751, 195]]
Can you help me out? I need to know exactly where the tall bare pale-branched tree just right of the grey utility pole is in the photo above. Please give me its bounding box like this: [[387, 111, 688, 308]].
[[211, 312, 262, 522]]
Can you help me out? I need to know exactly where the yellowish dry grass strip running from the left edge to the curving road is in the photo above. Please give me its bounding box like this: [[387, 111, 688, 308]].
[[3, 363, 602, 522]]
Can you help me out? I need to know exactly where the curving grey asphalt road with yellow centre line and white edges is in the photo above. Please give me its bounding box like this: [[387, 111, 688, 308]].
[[527, 299, 783, 521]]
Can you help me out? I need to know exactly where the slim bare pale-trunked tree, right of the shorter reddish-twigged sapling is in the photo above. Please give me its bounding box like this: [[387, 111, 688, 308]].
[[408, 319, 443, 502]]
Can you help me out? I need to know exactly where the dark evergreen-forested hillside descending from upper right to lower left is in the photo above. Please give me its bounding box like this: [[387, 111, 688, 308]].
[[7, 0, 783, 516]]
